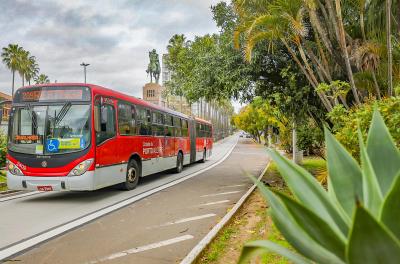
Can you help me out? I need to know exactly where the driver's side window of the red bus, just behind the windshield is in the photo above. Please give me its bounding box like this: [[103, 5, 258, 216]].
[[95, 104, 116, 145]]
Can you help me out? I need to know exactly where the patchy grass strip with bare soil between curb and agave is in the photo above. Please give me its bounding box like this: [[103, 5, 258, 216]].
[[196, 157, 326, 264]]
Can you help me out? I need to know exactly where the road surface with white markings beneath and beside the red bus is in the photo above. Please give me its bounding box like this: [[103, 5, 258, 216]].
[[0, 136, 268, 263]]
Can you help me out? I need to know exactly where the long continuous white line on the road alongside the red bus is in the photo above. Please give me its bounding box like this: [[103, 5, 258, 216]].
[[0, 138, 239, 261]]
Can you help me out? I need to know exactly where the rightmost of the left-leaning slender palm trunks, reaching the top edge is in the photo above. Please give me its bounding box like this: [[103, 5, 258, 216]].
[[327, 0, 361, 105]]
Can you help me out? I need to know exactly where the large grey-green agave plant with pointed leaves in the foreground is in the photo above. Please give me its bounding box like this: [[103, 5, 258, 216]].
[[239, 110, 400, 264]]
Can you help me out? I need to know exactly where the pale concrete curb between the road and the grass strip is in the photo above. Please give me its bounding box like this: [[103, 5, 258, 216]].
[[181, 160, 271, 264]]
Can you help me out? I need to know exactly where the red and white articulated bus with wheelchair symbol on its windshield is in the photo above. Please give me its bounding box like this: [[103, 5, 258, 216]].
[[7, 83, 213, 191]]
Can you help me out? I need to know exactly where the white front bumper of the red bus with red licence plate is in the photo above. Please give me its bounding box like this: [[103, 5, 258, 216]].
[[7, 171, 94, 191]]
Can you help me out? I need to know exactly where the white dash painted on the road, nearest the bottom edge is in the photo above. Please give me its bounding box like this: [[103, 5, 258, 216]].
[[88, 235, 194, 264]]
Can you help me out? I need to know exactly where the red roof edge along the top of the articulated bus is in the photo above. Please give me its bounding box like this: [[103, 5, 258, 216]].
[[19, 83, 211, 124]]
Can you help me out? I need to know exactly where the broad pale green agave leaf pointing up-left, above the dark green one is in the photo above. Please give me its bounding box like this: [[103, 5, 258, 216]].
[[268, 150, 349, 236]]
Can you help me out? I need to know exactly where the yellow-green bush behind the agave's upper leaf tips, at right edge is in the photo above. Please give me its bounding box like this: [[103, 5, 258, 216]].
[[328, 97, 400, 158]]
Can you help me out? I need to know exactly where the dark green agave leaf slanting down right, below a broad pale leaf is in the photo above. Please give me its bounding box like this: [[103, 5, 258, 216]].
[[274, 192, 346, 261]]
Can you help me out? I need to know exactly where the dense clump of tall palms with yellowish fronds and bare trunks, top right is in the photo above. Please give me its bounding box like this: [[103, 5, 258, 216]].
[[233, 0, 400, 111]]
